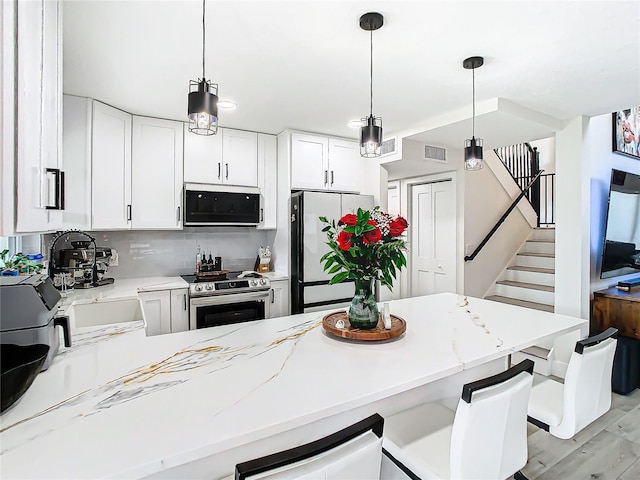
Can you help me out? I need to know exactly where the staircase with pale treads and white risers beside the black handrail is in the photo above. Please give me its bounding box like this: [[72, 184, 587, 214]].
[[485, 228, 555, 375]]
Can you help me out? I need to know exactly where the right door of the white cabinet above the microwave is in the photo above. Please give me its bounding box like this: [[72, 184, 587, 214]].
[[222, 128, 258, 187]]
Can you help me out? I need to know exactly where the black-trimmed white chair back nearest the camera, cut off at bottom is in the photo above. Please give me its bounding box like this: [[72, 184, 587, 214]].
[[235, 413, 384, 480]]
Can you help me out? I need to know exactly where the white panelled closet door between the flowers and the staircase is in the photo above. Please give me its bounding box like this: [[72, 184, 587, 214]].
[[409, 179, 457, 297]]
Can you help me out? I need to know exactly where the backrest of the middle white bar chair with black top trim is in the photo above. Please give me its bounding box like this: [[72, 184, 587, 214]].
[[450, 359, 533, 480]]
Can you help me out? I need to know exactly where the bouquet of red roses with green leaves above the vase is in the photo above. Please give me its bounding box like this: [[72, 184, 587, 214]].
[[320, 207, 408, 289]]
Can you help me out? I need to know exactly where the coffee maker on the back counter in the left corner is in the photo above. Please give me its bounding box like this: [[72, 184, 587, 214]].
[[49, 230, 114, 288]]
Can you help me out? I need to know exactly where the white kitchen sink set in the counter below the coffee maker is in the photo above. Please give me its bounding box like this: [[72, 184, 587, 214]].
[[67, 298, 142, 328]]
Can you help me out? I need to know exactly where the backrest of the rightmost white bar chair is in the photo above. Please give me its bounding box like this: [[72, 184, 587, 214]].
[[557, 328, 618, 438]]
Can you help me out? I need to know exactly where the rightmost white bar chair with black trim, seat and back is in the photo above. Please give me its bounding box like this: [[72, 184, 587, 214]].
[[528, 327, 618, 439]]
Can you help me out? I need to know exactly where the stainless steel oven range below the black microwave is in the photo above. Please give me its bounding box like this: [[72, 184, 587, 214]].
[[182, 272, 271, 330]]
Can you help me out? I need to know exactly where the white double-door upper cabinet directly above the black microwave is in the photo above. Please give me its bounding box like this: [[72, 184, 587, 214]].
[[184, 124, 258, 187]]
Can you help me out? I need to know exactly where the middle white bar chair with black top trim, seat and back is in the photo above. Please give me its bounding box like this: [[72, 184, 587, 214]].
[[382, 359, 533, 480]]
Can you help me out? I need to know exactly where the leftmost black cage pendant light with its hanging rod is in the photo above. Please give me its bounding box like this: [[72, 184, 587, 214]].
[[188, 0, 218, 135]]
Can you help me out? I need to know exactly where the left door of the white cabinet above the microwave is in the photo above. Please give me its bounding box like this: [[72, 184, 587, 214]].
[[184, 123, 223, 184]]
